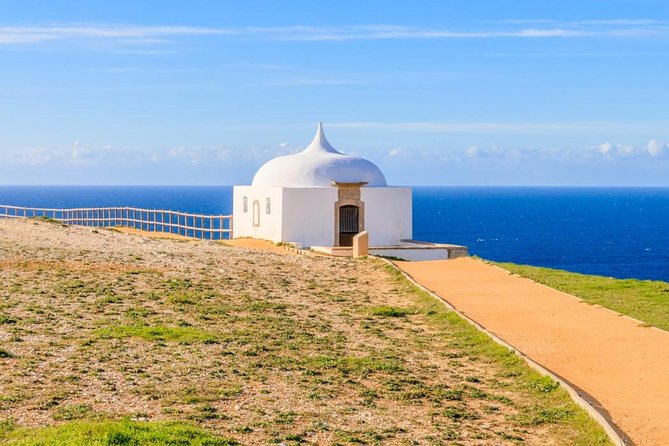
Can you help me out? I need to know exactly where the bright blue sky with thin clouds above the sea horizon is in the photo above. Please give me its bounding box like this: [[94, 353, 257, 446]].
[[0, 0, 669, 186]]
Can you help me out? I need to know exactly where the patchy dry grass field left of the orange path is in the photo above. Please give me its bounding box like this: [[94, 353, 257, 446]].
[[0, 221, 609, 446]]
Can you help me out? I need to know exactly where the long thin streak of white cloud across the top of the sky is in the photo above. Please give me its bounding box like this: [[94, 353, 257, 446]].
[[0, 19, 669, 45]]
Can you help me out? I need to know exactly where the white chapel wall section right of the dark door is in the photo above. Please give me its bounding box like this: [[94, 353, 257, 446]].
[[360, 187, 413, 246]]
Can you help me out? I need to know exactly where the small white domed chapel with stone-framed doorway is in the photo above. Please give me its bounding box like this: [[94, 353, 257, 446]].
[[233, 124, 412, 248]]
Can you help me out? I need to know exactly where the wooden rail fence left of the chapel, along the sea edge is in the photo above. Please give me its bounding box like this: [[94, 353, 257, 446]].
[[0, 205, 232, 240]]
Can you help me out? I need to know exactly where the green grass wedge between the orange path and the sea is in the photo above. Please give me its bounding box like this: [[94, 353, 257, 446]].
[[497, 263, 669, 330]]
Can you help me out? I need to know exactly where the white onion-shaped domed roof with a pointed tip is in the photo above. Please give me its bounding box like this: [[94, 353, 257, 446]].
[[252, 124, 386, 187]]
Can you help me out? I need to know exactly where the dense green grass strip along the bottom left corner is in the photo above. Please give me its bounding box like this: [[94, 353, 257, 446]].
[[0, 420, 238, 446]]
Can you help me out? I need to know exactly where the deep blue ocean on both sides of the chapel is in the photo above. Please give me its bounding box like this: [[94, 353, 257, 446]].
[[0, 186, 669, 281]]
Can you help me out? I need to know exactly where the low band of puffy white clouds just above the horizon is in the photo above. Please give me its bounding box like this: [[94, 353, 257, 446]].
[[0, 139, 669, 168]]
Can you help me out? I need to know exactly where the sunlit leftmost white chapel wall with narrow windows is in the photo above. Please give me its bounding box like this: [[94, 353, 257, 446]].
[[232, 186, 283, 242]]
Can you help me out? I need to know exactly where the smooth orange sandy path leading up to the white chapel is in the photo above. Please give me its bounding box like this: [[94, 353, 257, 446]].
[[397, 258, 669, 445]]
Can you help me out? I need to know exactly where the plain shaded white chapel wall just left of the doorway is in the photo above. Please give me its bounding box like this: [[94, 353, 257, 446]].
[[282, 187, 337, 247]]
